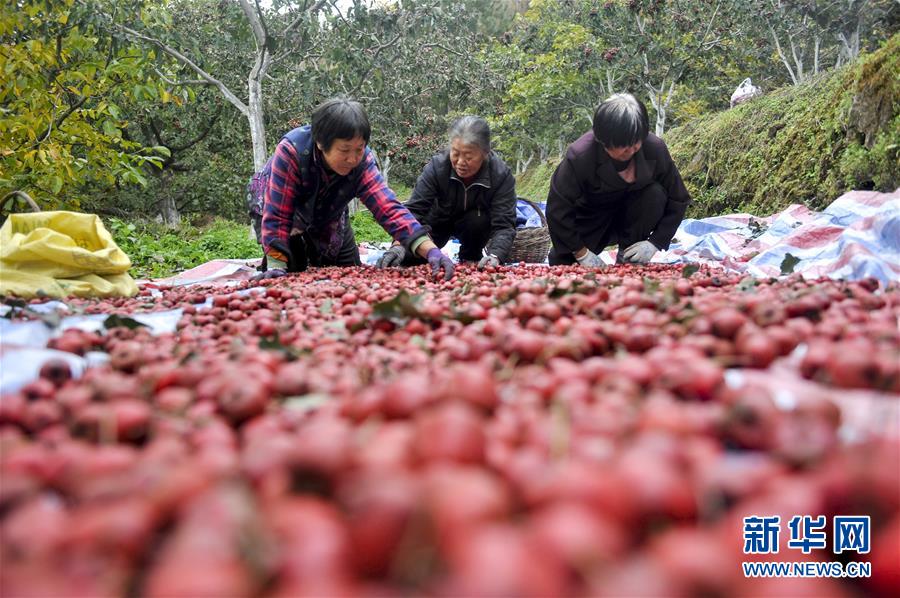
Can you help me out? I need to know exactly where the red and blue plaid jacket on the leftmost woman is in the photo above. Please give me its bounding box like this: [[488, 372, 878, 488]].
[[262, 125, 427, 262]]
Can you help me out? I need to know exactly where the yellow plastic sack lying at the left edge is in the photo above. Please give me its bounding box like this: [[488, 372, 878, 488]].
[[0, 211, 138, 298]]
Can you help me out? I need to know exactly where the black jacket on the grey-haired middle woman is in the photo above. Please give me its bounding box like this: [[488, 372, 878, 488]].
[[406, 150, 516, 261]]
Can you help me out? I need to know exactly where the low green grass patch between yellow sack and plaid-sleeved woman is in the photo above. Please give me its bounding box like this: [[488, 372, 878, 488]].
[[104, 218, 262, 278]]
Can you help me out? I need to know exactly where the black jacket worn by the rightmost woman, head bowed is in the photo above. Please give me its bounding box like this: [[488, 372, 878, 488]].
[[547, 131, 691, 252]]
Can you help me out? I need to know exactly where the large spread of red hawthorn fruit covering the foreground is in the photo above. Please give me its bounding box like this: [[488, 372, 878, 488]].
[[0, 265, 900, 598]]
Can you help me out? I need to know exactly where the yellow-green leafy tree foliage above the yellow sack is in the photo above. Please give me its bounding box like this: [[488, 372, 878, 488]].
[[0, 0, 182, 209]]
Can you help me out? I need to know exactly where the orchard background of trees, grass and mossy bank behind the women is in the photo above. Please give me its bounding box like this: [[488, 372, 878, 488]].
[[0, 0, 900, 275]]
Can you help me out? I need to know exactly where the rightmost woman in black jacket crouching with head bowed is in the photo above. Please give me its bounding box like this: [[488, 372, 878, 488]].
[[547, 93, 691, 267]]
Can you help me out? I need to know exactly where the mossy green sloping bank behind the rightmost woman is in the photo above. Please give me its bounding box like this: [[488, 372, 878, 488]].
[[666, 35, 900, 217]]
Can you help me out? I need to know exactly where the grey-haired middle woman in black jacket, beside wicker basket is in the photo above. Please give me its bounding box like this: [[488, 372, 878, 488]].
[[379, 116, 516, 268]]
